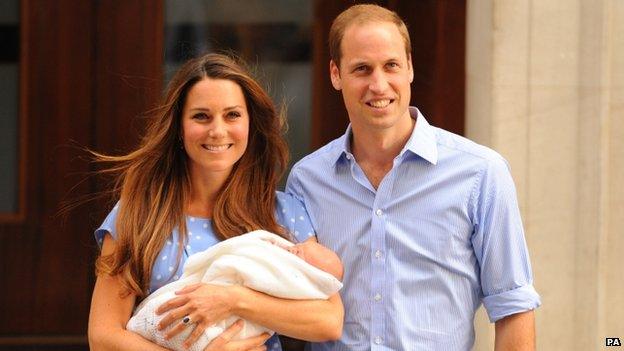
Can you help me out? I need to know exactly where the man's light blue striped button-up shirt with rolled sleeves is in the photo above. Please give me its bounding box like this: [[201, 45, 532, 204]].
[[287, 108, 540, 351]]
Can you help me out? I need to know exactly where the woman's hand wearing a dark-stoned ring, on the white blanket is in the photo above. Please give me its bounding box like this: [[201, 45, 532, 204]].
[[156, 283, 234, 347]]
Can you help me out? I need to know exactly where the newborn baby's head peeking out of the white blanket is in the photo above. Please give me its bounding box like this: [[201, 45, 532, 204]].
[[284, 240, 343, 281]]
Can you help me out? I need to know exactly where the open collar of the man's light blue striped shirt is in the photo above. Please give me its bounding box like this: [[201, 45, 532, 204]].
[[332, 106, 438, 165]]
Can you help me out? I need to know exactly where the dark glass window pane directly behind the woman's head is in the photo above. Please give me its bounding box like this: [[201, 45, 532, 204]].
[[164, 0, 312, 176]]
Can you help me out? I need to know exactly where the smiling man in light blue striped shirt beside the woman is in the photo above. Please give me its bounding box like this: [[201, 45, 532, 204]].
[[287, 5, 540, 350]]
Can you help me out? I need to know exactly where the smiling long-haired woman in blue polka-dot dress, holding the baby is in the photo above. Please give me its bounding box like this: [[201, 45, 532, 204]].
[[89, 54, 343, 350]]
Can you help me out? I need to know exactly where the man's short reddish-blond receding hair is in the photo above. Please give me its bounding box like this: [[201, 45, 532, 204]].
[[329, 4, 412, 66]]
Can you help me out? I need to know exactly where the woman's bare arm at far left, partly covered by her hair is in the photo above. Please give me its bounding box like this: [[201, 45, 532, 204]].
[[88, 235, 166, 351]]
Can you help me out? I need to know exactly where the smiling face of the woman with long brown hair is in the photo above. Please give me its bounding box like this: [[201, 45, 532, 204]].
[[182, 78, 249, 180]]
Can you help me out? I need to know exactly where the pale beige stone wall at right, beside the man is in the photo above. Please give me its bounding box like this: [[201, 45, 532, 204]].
[[466, 0, 624, 350]]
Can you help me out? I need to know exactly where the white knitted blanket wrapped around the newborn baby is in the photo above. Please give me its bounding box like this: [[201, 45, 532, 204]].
[[126, 230, 342, 350]]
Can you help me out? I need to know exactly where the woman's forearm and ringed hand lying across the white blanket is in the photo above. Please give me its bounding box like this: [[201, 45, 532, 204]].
[[156, 268, 344, 343]]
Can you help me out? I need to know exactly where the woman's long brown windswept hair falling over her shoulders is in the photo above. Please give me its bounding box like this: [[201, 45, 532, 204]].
[[94, 54, 288, 297]]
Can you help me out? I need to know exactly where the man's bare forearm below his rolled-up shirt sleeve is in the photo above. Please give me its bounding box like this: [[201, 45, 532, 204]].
[[494, 311, 535, 351]]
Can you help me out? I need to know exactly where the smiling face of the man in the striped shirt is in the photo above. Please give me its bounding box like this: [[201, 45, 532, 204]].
[[330, 22, 414, 130]]
